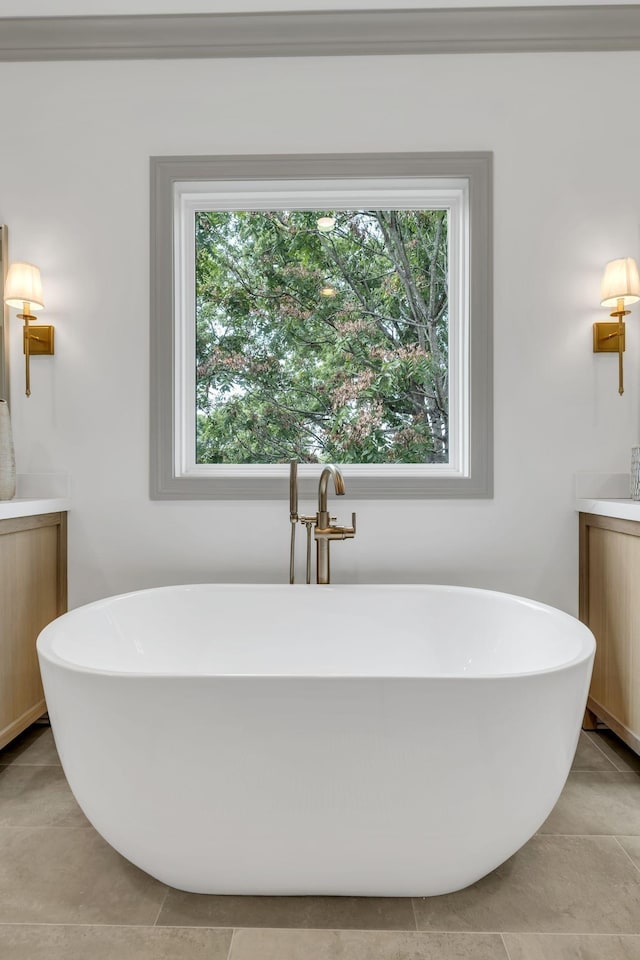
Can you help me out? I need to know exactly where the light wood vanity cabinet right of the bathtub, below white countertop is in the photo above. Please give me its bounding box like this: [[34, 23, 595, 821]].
[[580, 513, 640, 753]]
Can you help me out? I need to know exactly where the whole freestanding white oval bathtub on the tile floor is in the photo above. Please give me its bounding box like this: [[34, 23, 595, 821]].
[[38, 584, 595, 896]]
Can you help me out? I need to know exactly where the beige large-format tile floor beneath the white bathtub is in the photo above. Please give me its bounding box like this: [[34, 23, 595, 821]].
[[0, 726, 640, 960]]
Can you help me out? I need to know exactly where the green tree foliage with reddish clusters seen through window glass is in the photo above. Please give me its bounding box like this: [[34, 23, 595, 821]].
[[195, 210, 449, 464]]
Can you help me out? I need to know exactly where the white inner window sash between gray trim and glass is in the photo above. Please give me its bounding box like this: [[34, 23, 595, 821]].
[[173, 177, 470, 479]]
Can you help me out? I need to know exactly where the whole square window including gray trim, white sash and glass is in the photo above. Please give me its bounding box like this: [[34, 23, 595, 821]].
[[151, 154, 492, 499]]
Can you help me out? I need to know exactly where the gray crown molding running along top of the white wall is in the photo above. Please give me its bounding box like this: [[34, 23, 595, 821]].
[[0, 4, 640, 61]]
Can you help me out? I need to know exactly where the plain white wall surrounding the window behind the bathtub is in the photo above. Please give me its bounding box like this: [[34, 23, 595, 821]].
[[0, 53, 640, 611]]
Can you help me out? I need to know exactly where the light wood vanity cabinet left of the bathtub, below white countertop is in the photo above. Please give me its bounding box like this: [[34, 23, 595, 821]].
[[0, 512, 67, 748]]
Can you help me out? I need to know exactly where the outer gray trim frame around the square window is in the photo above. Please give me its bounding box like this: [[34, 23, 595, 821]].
[[150, 152, 493, 500]]
